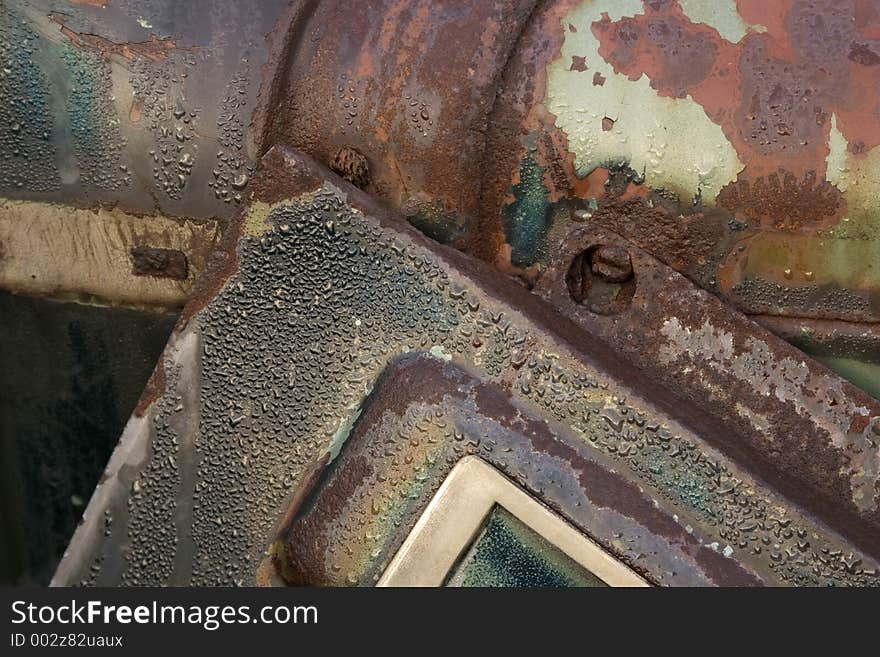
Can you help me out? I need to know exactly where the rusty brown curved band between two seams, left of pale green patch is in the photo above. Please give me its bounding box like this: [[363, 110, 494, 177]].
[[256, 0, 535, 246]]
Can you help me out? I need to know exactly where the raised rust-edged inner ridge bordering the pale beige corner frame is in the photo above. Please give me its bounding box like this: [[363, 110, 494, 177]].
[[276, 355, 762, 586]]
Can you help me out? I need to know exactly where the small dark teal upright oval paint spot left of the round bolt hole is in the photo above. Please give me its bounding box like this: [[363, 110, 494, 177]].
[[502, 155, 551, 267]]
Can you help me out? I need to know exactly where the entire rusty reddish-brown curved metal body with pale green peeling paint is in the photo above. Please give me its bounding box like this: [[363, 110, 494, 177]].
[[254, 0, 880, 338]]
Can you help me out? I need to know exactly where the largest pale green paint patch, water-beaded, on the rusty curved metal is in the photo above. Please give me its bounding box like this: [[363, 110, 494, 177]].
[[546, 0, 745, 205]]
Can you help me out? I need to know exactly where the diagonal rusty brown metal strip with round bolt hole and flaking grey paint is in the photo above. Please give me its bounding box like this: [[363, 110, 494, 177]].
[[535, 217, 880, 546]]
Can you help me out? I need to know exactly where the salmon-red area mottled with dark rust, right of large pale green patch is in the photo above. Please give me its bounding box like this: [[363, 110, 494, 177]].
[[592, 0, 880, 231]]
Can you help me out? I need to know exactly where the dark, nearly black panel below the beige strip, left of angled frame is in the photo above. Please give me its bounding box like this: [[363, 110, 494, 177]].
[[0, 292, 176, 584]]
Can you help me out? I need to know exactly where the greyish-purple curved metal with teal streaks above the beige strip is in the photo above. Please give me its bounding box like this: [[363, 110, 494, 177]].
[[0, 0, 288, 218]]
